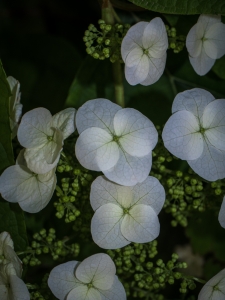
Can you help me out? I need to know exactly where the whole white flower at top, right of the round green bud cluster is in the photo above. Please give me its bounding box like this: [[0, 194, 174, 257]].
[[121, 17, 168, 85]]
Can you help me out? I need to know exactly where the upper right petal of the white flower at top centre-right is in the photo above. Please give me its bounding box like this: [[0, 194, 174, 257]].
[[142, 17, 168, 58]]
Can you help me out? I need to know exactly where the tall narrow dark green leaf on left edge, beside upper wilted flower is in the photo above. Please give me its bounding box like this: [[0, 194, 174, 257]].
[[0, 62, 14, 172]]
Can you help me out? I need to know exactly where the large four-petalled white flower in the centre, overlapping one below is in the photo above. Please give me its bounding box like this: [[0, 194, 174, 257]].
[[75, 99, 158, 186]]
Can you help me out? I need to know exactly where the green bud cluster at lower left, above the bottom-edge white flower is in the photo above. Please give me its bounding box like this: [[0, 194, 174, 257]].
[[20, 228, 80, 266]]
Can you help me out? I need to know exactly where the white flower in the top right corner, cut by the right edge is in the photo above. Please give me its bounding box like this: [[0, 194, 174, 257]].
[[186, 15, 225, 76]]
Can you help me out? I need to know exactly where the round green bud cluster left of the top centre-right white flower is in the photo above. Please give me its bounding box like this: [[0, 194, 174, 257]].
[[83, 20, 130, 63]]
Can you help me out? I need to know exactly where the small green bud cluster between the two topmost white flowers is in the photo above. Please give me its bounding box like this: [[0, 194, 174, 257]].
[[166, 25, 186, 53]]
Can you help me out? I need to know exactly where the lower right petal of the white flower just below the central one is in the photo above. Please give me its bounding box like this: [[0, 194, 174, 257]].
[[121, 204, 160, 243]]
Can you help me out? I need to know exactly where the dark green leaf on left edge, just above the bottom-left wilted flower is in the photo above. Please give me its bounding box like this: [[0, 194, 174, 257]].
[[0, 200, 28, 251]]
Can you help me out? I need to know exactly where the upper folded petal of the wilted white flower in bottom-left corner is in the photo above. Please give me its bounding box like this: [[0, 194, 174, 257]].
[[0, 231, 22, 276]]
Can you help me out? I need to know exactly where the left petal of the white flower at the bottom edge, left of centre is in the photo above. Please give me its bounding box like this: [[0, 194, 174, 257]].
[[48, 261, 82, 300]]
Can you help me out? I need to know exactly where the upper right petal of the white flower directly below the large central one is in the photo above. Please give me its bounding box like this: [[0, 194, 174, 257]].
[[131, 176, 166, 215]]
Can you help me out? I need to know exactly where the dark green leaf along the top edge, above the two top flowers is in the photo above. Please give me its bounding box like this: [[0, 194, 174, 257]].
[[129, 0, 225, 15]]
